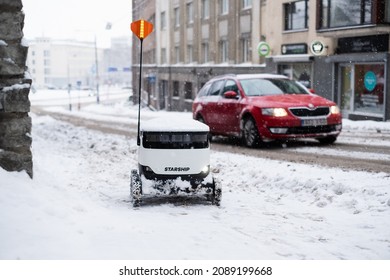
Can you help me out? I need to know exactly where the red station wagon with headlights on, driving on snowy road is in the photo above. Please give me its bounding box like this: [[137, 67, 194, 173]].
[[192, 74, 342, 147]]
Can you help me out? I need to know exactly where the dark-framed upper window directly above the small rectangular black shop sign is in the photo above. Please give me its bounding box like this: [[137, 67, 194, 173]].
[[284, 0, 308, 30]]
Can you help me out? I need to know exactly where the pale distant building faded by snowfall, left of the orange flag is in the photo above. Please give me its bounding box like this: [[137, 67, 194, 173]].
[[27, 37, 131, 88]]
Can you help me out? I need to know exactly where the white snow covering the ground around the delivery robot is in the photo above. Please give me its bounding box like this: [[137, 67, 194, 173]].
[[0, 91, 390, 260]]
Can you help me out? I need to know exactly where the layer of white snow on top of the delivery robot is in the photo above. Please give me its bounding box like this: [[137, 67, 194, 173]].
[[141, 117, 209, 132]]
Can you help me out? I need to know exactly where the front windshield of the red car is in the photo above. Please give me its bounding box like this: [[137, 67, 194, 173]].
[[241, 78, 308, 96]]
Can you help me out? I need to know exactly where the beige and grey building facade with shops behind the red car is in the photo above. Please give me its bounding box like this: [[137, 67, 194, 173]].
[[133, 0, 390, 120]]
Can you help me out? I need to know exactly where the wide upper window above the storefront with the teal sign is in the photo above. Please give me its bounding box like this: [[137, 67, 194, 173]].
[[320, 0, 373, 28]]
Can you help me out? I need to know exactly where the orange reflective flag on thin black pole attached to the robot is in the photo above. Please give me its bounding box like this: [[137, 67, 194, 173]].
[[130, 19, 153, 146]]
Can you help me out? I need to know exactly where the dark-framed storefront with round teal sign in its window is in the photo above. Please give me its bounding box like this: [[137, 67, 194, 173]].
[[329, 35, 390, 120]]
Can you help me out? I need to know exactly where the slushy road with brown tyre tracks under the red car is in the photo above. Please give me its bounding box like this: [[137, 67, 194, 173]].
[[32, 94, 390, 175]]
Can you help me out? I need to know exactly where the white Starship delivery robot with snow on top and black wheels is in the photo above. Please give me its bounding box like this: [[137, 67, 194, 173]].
[[130, 118, 222, 207]]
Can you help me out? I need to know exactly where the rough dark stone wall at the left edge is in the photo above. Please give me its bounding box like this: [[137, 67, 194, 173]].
[[0, 0, 33, 178]]
